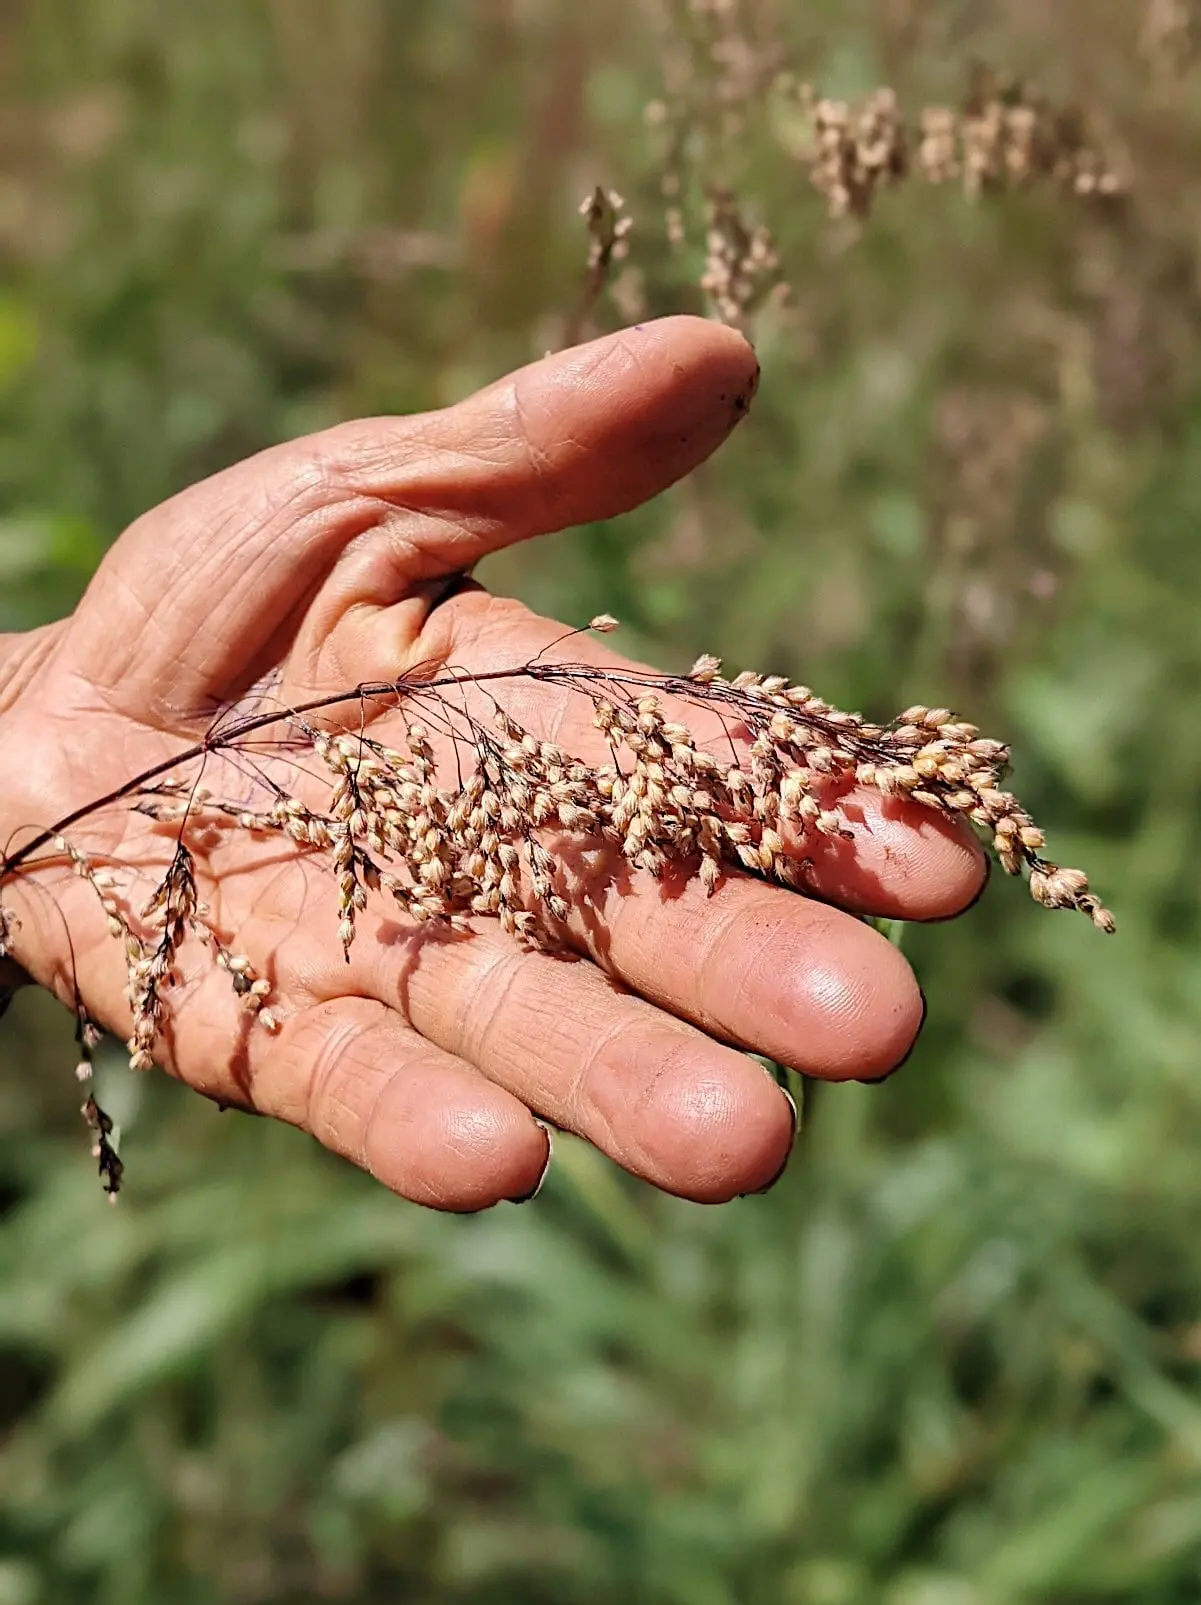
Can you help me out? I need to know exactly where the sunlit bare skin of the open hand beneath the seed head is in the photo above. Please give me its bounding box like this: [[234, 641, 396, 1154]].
[[0, 318, 984, 1210]]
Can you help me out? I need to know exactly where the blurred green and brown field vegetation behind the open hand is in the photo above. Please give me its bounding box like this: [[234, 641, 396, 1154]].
[[0, 0, 1201, 1605]]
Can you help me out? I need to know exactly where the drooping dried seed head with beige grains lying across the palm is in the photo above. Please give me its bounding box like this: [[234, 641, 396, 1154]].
[[0, 613, 1114, 1191]]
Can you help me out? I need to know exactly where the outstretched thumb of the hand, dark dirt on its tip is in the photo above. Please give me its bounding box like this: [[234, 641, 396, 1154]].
[[69, 318, 758, 722]]
